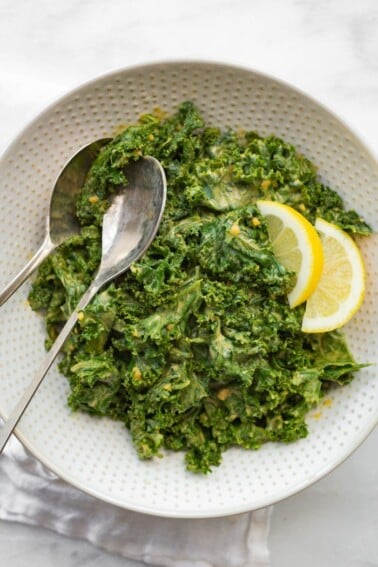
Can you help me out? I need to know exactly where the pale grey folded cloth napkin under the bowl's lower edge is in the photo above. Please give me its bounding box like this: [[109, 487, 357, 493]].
[[0, 436, 270, 567]]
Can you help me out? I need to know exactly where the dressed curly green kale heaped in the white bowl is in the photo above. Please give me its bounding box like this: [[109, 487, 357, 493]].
[[29, 102, 370, 473]]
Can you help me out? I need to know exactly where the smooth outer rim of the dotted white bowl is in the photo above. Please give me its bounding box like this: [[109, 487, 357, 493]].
[[0, 58, 378, 519]]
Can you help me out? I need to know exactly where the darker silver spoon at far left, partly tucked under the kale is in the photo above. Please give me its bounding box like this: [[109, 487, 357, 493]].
[[0, 138, 110, 305]]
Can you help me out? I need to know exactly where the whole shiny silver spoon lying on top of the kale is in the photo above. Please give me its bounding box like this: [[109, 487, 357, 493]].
[[0, 157, 167, 453]]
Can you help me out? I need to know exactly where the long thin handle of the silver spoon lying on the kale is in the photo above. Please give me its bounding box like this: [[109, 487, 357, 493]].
[[0, 280, 100, 453]]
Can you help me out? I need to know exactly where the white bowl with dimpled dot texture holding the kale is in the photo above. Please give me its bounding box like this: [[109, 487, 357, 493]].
[[0, 62, 378, 517]]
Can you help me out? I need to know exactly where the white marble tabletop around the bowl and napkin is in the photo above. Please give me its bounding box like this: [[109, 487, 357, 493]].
[[0, 0, 378, 567]]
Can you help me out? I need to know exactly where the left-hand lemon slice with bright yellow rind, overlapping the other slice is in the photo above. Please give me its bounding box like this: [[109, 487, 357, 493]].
[[257, 201, 323, 307]]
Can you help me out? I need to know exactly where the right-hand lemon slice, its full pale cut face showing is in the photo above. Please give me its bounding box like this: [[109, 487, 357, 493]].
[[302, 219, 365, 333]]
